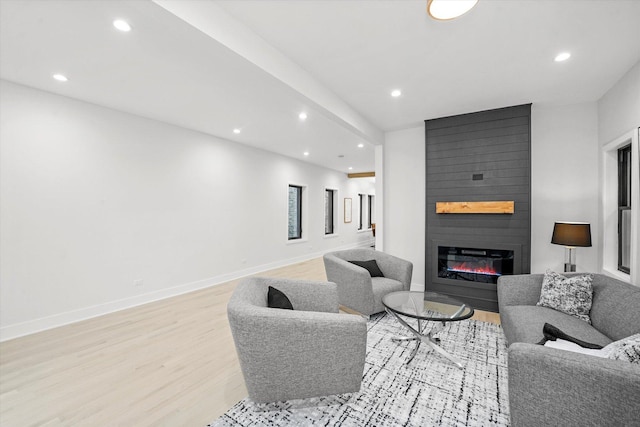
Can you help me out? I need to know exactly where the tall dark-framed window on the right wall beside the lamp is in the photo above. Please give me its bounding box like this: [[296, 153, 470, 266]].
[[618, 144, 631, 274]]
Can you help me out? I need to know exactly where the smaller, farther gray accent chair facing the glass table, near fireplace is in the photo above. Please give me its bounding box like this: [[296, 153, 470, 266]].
[[323, 248, 413, 316]]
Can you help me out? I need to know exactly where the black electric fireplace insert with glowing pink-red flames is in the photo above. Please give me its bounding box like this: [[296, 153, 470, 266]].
[[438, 246, 514, 283]]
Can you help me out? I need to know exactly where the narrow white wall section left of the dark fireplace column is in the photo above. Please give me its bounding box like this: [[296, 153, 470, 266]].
[[383, 125, 426, 290]]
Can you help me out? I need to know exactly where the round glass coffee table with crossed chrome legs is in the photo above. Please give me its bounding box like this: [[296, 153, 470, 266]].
[[382, 291, 473, 369]]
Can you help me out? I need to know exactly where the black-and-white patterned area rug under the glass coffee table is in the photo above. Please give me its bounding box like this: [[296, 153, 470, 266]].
[[209, 314, 509, 427]]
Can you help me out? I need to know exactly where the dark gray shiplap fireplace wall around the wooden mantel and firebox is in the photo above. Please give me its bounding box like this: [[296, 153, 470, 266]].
[[425, 104, 531, 311]]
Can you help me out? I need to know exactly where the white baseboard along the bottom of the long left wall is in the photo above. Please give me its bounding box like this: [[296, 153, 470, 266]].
[[0, 240, 373, 342]]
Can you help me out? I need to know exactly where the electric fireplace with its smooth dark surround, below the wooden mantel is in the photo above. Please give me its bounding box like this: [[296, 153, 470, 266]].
[[426, 239, 522, 312]]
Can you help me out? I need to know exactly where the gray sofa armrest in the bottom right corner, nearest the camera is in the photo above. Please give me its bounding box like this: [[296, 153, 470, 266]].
[[508, 343, 640, 427]]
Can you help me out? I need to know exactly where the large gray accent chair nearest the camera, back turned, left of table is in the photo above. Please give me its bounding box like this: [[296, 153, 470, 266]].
[[227, 277, 367, 403]]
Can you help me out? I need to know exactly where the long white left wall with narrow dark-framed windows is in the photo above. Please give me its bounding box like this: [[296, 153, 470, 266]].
[[0, 81, 375, 340]]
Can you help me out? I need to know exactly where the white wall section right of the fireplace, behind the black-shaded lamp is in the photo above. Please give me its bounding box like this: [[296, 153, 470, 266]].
[[531, 102, 602, 273]]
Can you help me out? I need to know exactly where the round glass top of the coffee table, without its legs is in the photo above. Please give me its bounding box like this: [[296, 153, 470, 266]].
[[382, 291, 473, 322]]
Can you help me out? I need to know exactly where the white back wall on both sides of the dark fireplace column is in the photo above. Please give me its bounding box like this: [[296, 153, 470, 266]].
[[384, 103, 599, 284]]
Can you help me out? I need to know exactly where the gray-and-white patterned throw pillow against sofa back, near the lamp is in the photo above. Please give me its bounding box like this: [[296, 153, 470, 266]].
[[537, 270, 593, 324]]
